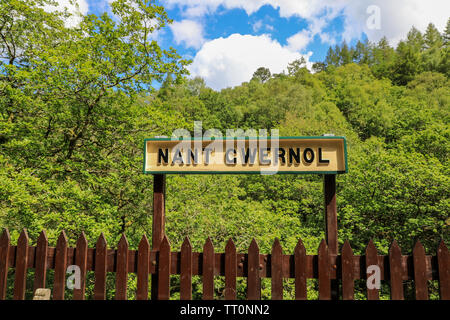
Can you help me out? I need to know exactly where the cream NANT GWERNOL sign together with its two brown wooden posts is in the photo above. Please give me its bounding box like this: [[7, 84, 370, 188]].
[[143, 136, 348, 299]]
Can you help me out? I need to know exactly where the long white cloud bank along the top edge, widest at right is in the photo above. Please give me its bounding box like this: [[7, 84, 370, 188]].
[[164, 0, 450, 44]]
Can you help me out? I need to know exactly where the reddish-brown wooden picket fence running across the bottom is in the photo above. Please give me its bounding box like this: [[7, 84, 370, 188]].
[[0, 230, 450, 300]]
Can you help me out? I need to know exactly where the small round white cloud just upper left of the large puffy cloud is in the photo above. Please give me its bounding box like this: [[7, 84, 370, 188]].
[[170, 20, 205, 49]]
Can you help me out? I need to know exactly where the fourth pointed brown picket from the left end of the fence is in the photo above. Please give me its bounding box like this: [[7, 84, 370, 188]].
[[52, 231, 68, 300]]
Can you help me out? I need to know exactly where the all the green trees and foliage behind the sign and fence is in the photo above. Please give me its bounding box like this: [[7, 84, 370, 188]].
[[0, 0, 450, 295]]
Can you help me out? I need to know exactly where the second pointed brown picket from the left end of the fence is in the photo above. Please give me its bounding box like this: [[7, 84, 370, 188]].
[[13, 229, 29, 300]]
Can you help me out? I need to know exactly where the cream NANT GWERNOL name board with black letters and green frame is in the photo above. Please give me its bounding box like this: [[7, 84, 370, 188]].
[[144, 136, 348, 174]]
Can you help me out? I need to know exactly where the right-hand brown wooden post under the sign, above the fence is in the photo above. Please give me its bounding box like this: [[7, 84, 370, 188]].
[[324, 174, 338, 255]]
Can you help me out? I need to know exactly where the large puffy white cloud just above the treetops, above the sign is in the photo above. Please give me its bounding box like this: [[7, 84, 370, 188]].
[[189, 34, 310, 90]]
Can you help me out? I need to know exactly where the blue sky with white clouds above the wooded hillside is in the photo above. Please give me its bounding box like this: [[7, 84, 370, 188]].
[[47, 0, 450, 90]]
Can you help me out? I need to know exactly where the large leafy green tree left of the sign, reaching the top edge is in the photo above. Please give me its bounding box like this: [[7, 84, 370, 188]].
[[0, 0, 187, 239]]
